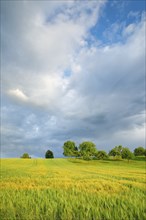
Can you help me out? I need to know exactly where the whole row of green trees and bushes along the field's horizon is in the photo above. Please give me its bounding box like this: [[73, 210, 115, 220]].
[[21, 141, 146, 161]]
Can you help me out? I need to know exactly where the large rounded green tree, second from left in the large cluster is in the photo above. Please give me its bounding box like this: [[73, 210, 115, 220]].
[[79, 141, 97, 160]]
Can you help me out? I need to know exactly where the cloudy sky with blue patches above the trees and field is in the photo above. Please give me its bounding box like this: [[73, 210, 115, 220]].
[[1, 0, 146, 158]]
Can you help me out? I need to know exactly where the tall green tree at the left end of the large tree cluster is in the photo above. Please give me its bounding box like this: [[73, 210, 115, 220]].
[[63, 141, 78, 157]]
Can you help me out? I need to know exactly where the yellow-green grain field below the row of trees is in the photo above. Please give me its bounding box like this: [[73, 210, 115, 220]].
[[0, 159, 146, 220]]
